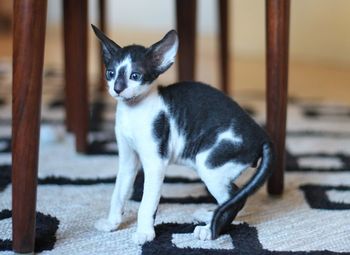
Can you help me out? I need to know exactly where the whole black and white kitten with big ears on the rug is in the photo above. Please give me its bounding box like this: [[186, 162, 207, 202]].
[[92, 26, 273, 244]]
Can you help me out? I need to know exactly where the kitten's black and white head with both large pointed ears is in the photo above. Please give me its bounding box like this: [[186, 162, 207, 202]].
[[92, 25, 179, 101]]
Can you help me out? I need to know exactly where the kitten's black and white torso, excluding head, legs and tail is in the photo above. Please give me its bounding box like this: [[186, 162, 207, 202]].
[[116, 82, 267, 168]]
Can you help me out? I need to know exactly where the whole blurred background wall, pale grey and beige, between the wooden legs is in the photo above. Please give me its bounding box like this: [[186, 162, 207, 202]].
[[49, 0, 350, 66]]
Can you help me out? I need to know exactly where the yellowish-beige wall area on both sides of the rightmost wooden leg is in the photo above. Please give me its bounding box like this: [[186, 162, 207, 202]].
[[231, 0, 350, 65]]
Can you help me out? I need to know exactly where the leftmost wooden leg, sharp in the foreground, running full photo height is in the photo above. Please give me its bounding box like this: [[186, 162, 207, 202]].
[[12, 0, 47, 253]]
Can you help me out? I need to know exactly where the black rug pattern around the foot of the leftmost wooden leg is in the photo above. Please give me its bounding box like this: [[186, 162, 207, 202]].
[[0, 209, 59, 252]]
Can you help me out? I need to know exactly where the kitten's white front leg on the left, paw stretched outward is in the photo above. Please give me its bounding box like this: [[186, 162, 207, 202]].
[[95, 136, 140, 232]]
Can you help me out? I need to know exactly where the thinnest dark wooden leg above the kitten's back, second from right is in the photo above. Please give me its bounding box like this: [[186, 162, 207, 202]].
[[218, 0, 230, 94]]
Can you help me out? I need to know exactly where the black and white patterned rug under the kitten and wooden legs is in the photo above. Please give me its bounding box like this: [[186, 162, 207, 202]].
[[0, 62, 350, 255]]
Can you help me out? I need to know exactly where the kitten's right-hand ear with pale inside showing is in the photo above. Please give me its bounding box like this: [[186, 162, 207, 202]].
[[148, 30, 179, 74]]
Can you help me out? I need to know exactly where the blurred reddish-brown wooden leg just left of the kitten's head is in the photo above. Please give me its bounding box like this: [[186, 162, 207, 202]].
[[63, 0, 89, 152]]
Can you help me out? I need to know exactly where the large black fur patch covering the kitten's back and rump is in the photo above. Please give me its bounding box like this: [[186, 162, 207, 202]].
[[159, 82, 269, 163]]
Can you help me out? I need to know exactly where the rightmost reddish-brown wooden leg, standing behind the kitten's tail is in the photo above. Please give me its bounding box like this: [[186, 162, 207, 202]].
[[266, 0, 290, 195]]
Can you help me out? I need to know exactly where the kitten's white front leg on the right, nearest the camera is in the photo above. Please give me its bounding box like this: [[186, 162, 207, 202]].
[[134, 157, 165, 244]]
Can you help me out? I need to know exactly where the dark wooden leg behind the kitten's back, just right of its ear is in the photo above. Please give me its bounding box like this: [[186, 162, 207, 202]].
[[176, 0, 197, 81]]
